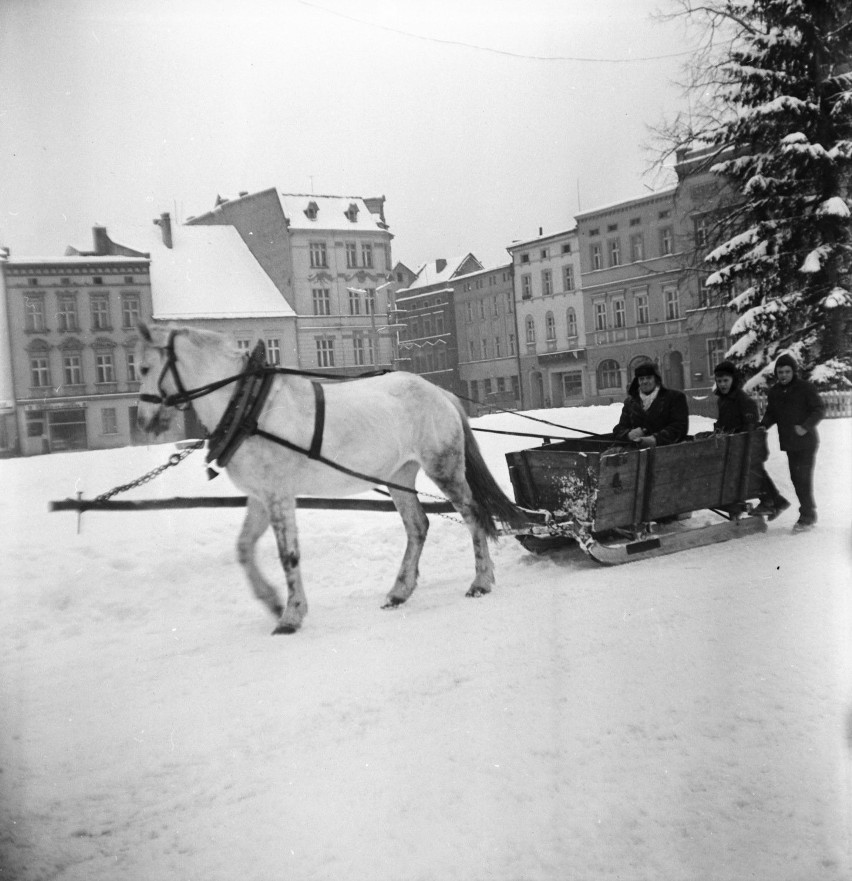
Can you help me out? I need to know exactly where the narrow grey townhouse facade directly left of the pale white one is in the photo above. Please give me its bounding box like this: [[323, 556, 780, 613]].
[[450, 263, 522, 413]]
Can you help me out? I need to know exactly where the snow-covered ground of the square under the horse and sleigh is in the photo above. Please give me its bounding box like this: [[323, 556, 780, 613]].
[[0, 407, 852, 881]]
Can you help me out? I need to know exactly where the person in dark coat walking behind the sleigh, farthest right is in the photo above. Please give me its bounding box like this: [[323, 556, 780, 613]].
[[760, 352, 825, 532]]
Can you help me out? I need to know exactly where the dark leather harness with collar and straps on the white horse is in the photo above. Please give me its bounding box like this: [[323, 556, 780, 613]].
[[147, 330, 417, 495]]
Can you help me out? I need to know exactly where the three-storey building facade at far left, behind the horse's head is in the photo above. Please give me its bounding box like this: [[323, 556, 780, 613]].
[[3, 257, 182, 455]]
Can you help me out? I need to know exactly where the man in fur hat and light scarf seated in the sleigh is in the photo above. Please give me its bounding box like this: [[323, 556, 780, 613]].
[[613, 362, 689, 447]]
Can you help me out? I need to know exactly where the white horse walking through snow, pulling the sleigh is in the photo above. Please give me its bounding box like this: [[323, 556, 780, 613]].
[[138, 325, 524, 633]]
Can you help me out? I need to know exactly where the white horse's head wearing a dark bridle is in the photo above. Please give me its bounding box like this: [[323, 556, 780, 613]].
[[136, 323, 181, 435]]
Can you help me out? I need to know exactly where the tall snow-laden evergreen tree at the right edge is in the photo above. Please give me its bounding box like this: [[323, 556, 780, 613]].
[[669, 0, 852, 388]]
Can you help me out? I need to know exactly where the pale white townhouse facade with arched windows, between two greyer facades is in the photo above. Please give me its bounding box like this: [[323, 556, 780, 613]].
[[507, 229, 590, 409]]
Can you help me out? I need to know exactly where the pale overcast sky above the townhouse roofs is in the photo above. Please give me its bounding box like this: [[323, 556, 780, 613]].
[[0, 0, 689, 269]]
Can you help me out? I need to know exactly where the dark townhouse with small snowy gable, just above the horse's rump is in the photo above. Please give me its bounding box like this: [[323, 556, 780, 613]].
[[395, 254, 482, 394]]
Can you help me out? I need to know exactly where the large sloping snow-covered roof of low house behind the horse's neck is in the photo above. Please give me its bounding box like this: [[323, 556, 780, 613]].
[[107, 223, 295, 321]]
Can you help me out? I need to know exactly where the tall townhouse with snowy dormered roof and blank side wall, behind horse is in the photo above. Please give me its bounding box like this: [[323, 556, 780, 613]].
[[186, 189, 394, 375]]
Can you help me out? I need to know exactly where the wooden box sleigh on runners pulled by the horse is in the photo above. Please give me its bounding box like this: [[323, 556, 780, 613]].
[[506, 429, 766, 565]]
